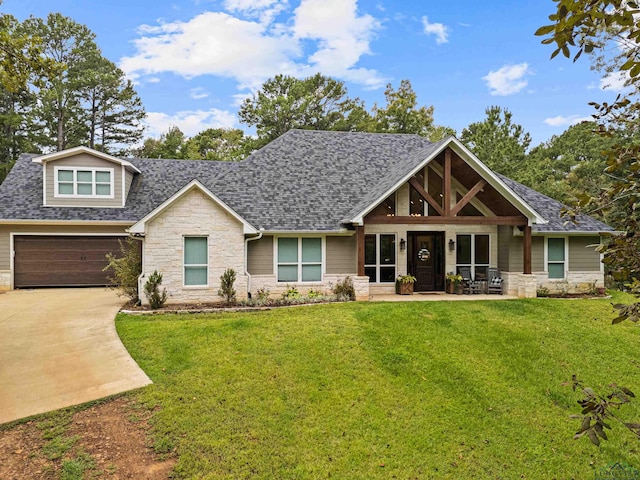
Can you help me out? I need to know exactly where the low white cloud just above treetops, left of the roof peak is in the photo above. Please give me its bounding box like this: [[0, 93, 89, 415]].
[[145, 108, 237, 138]]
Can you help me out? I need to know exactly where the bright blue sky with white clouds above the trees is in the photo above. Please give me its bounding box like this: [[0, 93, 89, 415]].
[[0, 0, 622, 146]]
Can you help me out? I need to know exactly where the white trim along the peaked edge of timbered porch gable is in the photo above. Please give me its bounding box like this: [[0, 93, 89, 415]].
[[350, 137, 548, 225]]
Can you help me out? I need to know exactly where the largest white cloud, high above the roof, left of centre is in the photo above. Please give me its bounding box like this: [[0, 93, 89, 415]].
[[120, 0, 387, 91]]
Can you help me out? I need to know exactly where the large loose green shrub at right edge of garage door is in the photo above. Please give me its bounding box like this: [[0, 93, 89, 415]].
[[102, 237, 142, 302]]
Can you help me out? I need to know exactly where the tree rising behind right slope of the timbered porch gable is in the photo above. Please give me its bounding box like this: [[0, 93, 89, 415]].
[[460, 106, 531, 180]]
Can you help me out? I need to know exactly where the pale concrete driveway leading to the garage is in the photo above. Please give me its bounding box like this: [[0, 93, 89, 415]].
[[0, 288, 151, 423]]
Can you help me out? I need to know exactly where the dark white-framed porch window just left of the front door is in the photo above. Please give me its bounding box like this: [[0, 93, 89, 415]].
[[364, 233, 396, 283]]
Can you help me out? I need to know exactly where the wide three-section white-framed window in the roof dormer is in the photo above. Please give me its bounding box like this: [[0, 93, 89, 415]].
[[54, 167, 114, 198]]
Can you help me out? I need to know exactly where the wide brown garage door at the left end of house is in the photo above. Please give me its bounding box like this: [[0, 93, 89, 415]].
[[13, 236, 127, 288]]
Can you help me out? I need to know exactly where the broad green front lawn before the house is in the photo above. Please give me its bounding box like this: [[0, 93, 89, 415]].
[[116, 299, 640, 479]]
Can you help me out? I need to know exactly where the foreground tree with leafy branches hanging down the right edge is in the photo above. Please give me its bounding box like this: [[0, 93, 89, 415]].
[[536, 0, 640, 445]]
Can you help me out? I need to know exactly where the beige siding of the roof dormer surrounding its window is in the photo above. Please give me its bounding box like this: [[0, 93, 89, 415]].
[[44, 154, 122, 207]]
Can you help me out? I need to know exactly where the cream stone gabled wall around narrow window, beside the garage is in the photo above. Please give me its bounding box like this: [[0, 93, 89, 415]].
[[140, 188, 247, 304]]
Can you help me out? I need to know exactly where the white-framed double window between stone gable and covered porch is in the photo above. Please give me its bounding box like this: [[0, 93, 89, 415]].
[[276, 237, 322, 283]]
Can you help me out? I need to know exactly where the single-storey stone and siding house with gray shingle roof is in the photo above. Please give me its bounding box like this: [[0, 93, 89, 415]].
[[0, 130, 611, 302]]
